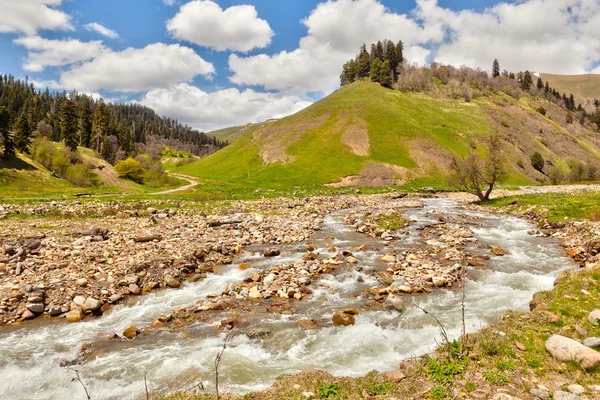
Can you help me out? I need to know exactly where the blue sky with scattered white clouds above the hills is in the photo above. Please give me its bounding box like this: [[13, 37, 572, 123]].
[[0, 0, 600, 131]]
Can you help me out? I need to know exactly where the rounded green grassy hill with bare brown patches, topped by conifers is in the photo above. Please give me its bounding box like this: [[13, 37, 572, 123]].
[[177, 82, 600, 190]]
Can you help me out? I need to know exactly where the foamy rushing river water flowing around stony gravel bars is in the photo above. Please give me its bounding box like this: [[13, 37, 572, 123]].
[[0, 199, 573, 400]]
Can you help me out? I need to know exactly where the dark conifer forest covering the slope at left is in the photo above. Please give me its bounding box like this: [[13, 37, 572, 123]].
[[0, 75, 227, 163]]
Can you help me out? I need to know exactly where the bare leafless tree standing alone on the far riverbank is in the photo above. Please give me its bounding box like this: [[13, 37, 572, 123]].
[[450, 133, 506, 201]]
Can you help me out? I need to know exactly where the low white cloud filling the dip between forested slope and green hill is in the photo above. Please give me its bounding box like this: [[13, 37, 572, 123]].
[[140, 83, 311, 131]]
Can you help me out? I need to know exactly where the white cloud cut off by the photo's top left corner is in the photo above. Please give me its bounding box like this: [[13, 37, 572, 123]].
[[0, 0, 73, 36]]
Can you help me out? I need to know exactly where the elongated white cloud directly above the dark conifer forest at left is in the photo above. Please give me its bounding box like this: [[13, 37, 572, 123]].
[[58, 43, 215, 92]]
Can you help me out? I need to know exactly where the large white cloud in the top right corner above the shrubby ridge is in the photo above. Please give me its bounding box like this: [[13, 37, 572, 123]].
[[415, 0, 600, 74]]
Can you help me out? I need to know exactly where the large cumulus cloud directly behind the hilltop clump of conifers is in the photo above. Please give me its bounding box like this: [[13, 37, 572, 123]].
[[229, 0, 444, 94]]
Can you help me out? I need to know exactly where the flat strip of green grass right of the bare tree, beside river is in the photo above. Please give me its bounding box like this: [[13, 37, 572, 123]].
[[485, 193, 600, 221]]
